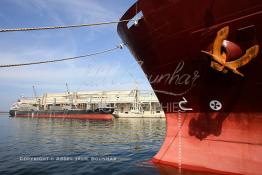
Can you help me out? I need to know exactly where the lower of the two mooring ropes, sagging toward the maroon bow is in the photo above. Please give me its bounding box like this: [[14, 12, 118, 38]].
[[0, 44, 124, 68]]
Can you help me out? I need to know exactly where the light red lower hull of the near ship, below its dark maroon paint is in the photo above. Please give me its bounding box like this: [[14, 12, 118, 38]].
[[153, 113, 262, 174]]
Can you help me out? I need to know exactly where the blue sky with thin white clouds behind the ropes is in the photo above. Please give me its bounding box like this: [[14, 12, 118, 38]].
[[0, 0, 150, 111]]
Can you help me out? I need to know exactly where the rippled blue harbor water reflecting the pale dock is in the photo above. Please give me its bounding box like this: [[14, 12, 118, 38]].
[[0, 114, 214, 175]]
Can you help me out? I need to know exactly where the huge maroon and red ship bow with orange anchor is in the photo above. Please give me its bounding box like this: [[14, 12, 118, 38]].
[[118, 0, 262, 175]]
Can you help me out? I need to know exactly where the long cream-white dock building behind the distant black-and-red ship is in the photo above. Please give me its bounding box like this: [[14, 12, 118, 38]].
[[20, 89, 165, 117]]
